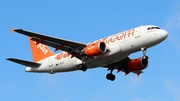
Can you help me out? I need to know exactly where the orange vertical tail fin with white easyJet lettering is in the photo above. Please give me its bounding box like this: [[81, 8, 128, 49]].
[[29, 37, 54, 62]]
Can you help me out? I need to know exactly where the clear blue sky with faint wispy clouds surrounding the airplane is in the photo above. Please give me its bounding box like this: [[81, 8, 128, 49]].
[[0, 0, 180, 101]]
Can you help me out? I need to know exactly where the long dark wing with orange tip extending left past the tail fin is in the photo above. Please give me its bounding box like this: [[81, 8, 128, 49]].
[[11, 29, 86, 58]]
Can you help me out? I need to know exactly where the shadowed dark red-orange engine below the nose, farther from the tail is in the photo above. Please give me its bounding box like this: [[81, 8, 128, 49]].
[[128, 57, 148, 72]]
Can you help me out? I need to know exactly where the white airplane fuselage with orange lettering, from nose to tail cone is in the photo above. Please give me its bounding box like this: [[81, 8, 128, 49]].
[[26, 25, 167, 73]]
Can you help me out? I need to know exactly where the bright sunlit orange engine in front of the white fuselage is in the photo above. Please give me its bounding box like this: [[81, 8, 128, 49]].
[[84, 42, 107, 56]]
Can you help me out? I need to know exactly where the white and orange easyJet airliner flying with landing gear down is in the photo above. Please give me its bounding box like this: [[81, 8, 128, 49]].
[[7, 25, 168, 81]]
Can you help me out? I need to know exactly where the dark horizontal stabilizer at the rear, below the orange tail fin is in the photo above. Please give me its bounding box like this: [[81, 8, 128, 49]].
[[7, 58, 41, 68]]
